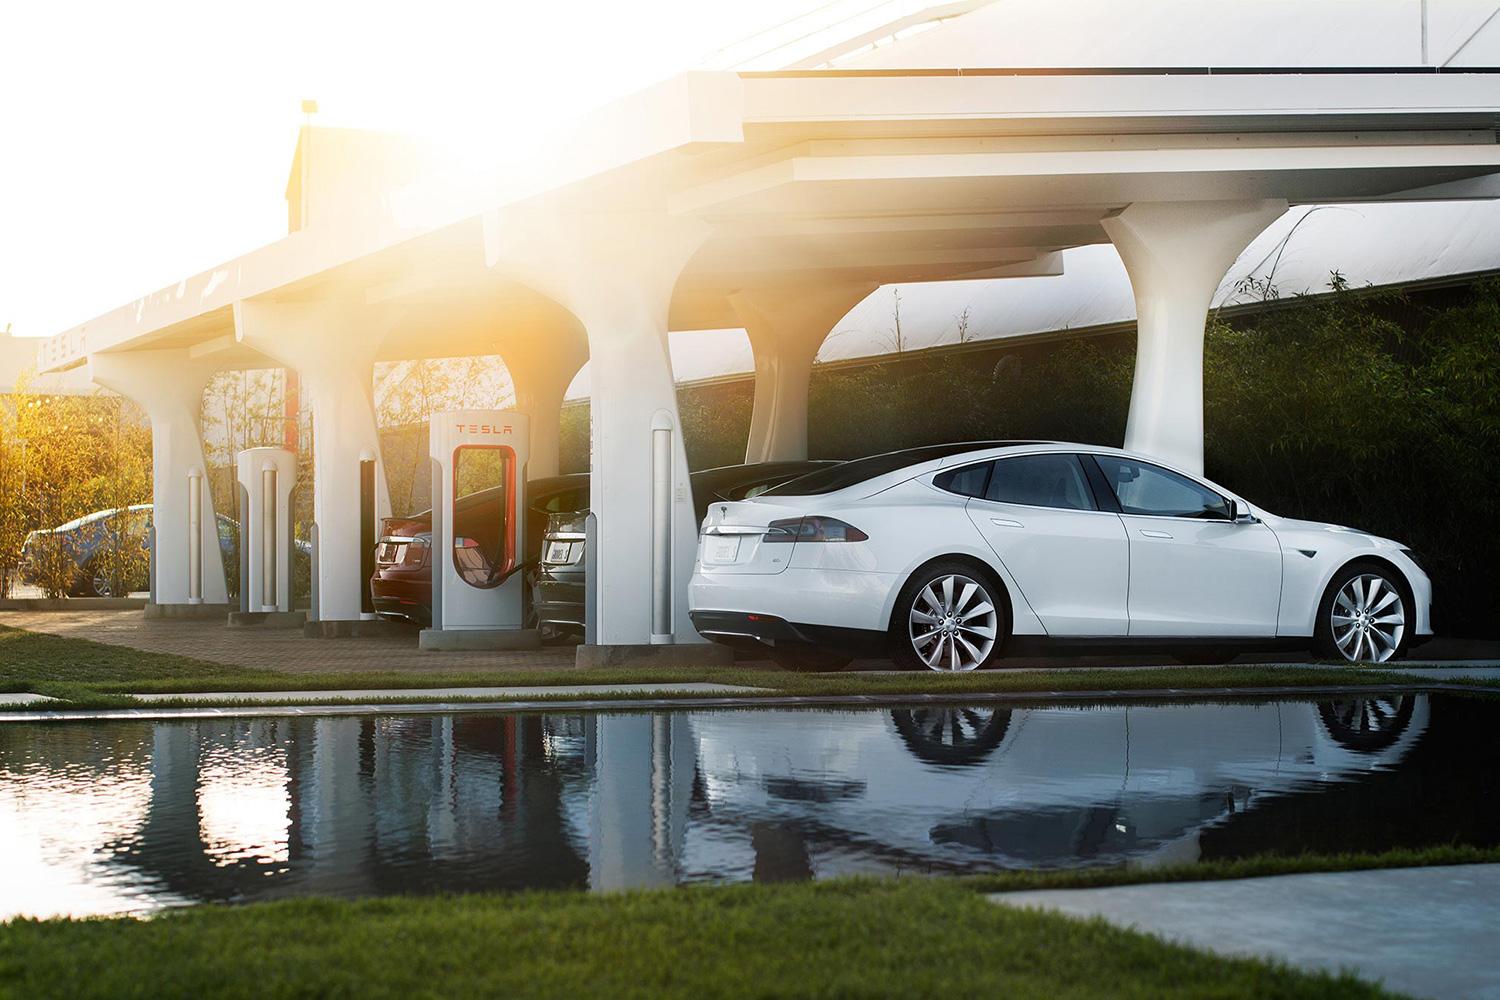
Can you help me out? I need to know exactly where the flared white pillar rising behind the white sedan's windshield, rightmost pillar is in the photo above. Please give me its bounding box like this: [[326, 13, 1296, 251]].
[[1103, 199, 1287, 474]]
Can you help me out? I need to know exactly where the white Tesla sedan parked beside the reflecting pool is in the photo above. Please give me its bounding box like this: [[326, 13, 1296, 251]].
[[690, 441, 1433, 670]]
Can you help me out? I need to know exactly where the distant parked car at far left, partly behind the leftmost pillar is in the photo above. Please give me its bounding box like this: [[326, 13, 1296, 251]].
[[21, 504, 247, 597]]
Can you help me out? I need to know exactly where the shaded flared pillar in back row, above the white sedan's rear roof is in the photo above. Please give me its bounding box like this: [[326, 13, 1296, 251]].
[[729, 282, 878, 462]]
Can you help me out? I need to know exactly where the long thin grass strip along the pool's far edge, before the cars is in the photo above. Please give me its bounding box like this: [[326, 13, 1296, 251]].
[[0, 625, 1493, 708]]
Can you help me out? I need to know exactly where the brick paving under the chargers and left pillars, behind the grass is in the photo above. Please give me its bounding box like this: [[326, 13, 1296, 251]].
[[0, 610, 585, 675]]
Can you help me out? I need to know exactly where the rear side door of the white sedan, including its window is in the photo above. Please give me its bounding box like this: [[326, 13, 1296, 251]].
[[960, 453, 1130, 636]]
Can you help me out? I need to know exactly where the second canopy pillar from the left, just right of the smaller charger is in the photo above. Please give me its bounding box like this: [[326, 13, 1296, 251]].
[[234, 301, 390, 622]]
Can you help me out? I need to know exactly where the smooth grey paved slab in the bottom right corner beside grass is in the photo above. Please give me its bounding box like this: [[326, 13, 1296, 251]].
[[990, 865, 1500, 1000]]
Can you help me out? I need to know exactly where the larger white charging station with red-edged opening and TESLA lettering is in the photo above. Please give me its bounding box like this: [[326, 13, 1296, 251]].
[[419, 409, 540, 649]]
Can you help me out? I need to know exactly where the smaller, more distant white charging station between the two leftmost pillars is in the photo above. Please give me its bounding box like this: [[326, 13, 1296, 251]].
[[234, 448, 297, 615]]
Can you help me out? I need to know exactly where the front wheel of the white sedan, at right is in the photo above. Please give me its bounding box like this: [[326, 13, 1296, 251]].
[[1313, 562, 1416, 663]]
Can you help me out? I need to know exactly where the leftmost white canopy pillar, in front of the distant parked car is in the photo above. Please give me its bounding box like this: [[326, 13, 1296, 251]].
[[89, 349, 230, 613]]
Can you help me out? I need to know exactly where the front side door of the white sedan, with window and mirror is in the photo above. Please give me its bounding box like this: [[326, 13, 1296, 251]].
[[1092, 454, 1281, 637]]
